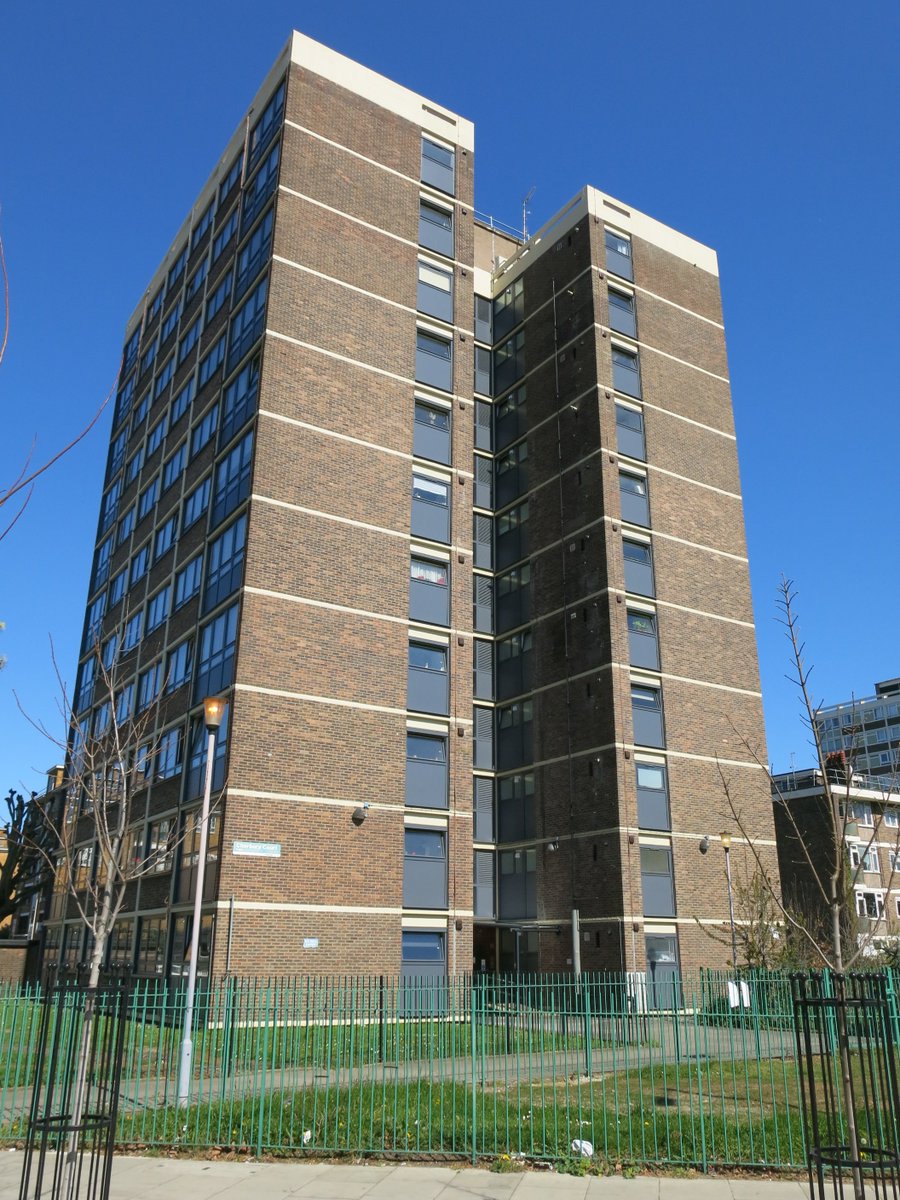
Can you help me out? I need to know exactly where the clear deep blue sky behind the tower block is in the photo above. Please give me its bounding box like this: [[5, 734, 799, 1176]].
[[0, 0, 900, 788]]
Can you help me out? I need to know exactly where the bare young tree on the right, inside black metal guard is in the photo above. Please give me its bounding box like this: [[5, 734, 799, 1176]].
[[719, 576, 900, 1200]]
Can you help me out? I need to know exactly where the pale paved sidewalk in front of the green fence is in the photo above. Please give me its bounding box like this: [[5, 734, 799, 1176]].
[[0, 1150, 809, 1200]]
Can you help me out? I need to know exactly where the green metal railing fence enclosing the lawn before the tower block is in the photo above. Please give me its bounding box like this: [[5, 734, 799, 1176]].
[[0, 972, 883, 1169]]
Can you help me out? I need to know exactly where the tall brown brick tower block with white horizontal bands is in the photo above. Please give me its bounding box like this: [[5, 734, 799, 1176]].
[[49, 34, 774, 976]]
